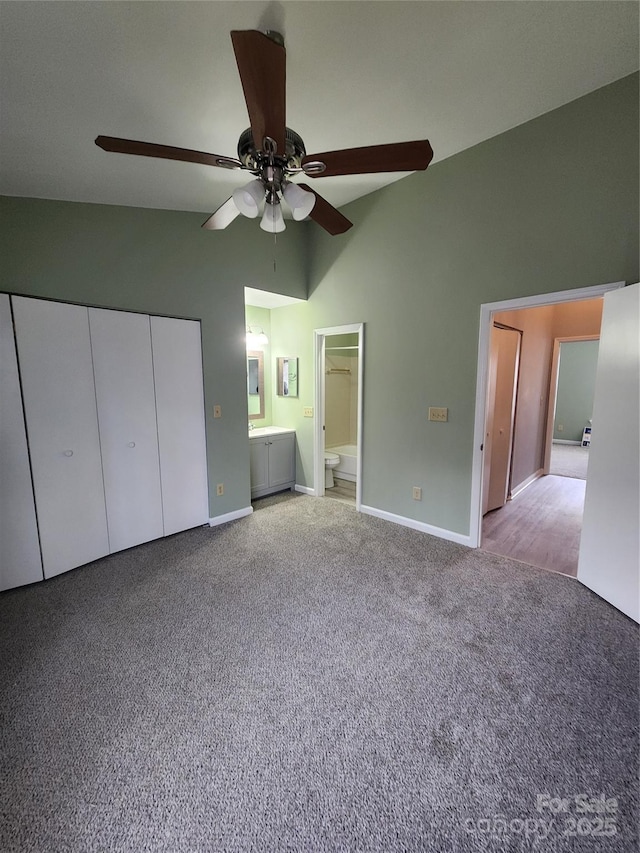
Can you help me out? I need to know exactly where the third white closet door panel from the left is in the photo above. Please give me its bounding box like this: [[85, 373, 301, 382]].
[[89, 308, 163, 552]]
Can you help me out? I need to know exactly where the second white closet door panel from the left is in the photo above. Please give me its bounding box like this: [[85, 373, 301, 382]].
[[12, 296, 109, 578]]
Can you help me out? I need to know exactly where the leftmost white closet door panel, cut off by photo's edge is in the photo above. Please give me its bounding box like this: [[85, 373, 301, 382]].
[[0, 293, 42, 590]]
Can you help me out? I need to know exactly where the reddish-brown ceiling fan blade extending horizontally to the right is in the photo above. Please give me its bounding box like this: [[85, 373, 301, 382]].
[[302, 139, 433, 178]]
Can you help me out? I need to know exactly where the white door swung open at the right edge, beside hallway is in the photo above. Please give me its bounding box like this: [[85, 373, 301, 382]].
[[578, 284, 640, 622]]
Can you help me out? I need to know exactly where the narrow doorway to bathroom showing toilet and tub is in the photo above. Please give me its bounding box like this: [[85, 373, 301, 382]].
[[314, 323, 364, 511]]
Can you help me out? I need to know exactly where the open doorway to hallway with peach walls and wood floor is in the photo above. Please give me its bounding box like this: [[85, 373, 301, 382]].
[[471, 285, 619, 576]]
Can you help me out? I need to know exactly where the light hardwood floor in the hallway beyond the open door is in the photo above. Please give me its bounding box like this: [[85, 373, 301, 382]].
[[480, 474, 586, 577]]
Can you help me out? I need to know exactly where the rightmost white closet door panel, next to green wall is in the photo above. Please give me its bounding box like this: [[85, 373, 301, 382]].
[[151, 317, 209, 536]]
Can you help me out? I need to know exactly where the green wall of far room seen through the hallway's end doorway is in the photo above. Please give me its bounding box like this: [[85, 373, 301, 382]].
[[553, 341, 600, 441]]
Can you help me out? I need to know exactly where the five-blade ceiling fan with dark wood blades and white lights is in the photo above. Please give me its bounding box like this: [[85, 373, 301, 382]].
[[95, 30, 433, 234]]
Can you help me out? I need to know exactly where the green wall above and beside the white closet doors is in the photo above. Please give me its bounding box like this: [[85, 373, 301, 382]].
[[0, 197, 308, 516]]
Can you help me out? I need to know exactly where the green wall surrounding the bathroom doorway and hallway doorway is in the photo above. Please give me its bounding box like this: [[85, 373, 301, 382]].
[[272, 74, 639, 534]]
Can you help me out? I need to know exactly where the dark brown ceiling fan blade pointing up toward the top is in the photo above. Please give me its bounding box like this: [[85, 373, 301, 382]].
[[231, 30, 287, 155]]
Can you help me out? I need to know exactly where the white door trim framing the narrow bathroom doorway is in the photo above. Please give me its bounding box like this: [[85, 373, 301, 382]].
[[313, 323, 364, 512]]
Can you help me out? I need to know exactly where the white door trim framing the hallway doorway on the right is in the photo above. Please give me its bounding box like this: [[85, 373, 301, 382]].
[[469, 281, 625, 548]]
